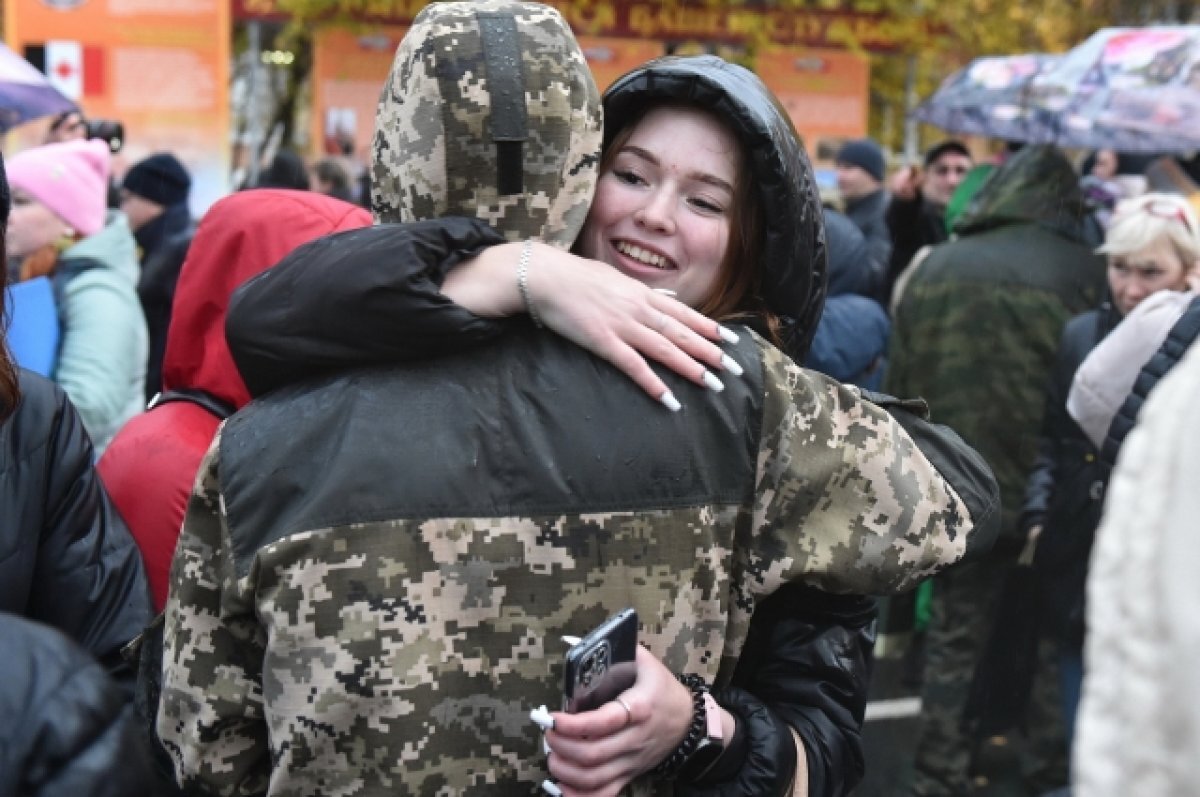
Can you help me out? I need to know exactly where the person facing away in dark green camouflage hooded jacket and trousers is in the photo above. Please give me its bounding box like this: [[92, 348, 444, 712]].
[[886, 146, 1105, 795]]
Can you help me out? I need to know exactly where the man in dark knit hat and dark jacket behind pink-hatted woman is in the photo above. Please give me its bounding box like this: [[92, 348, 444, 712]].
[[121, 152, 193, 401]]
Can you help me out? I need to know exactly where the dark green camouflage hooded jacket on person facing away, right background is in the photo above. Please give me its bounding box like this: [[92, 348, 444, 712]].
[[884, 146, 1105, 553]]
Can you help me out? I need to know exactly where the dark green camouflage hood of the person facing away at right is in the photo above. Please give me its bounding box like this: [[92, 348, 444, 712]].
[[954, 144, 1086, 241]]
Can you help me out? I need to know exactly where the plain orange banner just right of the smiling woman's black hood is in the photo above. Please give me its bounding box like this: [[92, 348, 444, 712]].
[[756, 47, 871, 155]]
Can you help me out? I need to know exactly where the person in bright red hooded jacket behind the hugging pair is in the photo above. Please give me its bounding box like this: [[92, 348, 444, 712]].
[[97, 190, 371, 611]]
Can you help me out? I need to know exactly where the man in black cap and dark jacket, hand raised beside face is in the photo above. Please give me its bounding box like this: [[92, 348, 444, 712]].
[[883, 138, 974, 304]]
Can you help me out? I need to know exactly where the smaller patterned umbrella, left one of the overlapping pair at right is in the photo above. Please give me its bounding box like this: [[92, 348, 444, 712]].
[[913, 54, 1058, 140]]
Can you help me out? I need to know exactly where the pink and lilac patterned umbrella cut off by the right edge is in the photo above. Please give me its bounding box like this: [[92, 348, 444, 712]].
[[1030, 25, 1200, 152]]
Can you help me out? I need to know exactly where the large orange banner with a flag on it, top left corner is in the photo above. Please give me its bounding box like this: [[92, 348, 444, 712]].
[[5, 0, 230, 215]]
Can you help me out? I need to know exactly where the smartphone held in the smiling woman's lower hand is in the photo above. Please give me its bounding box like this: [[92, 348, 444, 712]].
[[563, 609, 637, 714]]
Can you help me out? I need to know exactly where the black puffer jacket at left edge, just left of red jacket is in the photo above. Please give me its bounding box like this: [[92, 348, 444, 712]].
[[0, 371, 152, 694]]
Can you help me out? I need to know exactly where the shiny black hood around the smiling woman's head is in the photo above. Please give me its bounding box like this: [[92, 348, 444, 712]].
[[604, 55, 826, 361]]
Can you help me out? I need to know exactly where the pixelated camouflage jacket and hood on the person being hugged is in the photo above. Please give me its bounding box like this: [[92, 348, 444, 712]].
[[157, 0, 994, 797]]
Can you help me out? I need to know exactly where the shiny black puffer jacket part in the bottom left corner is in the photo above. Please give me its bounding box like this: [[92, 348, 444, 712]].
[[0, 613, 151, 797]]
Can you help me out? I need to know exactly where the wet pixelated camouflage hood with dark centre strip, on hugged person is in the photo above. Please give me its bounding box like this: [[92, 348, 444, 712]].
[[371, 0, 602, 248]]
